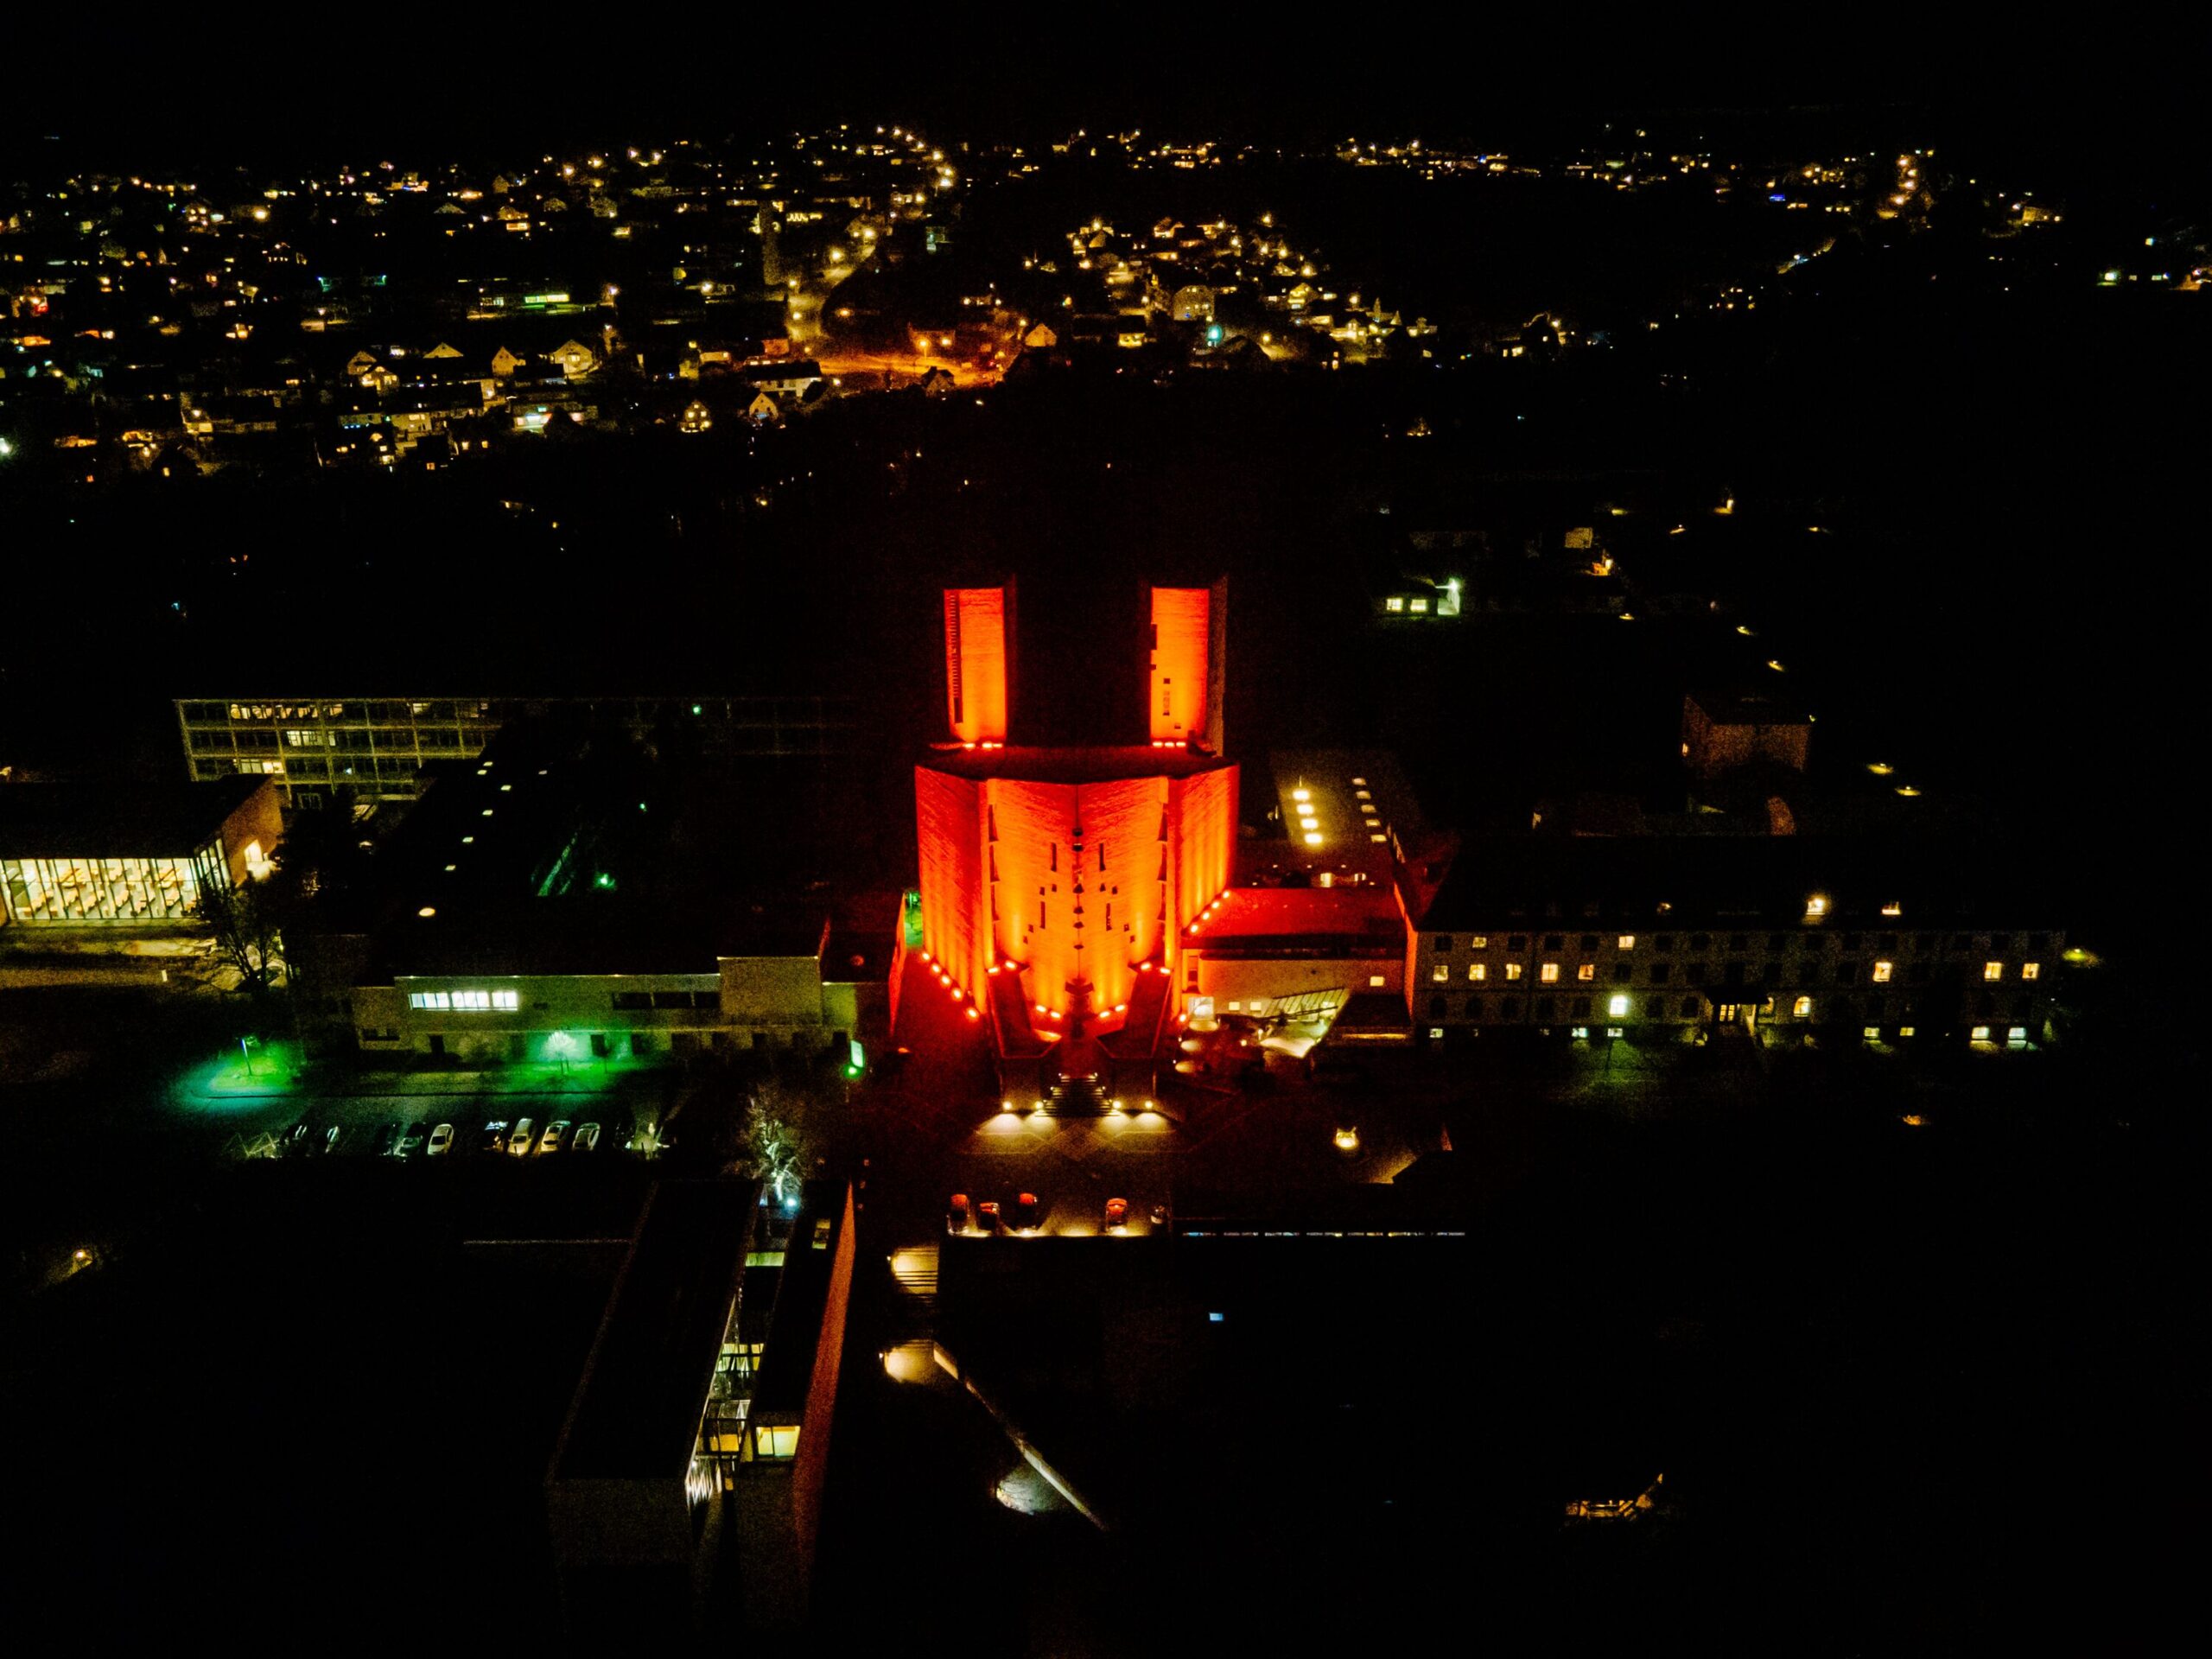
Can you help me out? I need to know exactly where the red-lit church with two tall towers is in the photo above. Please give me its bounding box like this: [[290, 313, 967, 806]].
[[913, 582, 1236, 1089]]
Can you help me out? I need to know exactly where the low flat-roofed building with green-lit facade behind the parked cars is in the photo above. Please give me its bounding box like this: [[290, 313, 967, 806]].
[[288, 710, 898, 1064]]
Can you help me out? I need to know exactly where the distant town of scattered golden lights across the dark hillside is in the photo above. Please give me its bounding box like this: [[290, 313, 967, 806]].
[[0, 126, 2212, 473]]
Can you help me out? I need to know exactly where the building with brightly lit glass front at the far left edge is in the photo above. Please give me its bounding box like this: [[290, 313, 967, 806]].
[[0, 774, 283, 927]]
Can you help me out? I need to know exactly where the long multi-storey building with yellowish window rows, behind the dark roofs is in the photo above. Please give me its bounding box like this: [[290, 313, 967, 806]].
[[177, 696, 854, 807]]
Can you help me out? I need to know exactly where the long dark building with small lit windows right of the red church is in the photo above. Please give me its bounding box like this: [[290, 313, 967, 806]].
[[1407, 836, 2066, 1044]]
